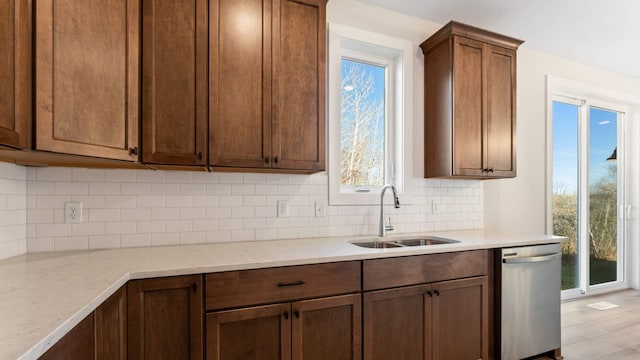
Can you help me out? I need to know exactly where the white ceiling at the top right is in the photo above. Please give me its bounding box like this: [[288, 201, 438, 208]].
[[360, 0, 640, 79]]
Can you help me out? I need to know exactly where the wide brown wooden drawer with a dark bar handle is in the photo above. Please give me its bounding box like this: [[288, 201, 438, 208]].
[[205, 261, 361, 310]]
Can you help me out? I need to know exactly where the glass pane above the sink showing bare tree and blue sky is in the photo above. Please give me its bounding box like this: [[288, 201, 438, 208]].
[[340, 59, 386, 189]]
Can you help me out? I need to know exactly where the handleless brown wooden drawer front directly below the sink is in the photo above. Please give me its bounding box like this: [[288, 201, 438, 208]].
[[362, 250, 489, 291]]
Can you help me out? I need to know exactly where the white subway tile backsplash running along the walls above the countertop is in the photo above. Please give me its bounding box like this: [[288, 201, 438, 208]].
[[0, 163, 484, 255]]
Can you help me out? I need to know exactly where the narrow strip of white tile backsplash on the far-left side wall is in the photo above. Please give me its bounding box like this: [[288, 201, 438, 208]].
[[0, 162, 27, 259]]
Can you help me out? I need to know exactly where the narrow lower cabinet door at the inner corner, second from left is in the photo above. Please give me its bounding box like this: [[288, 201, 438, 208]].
[[94, 287, 127, 360]]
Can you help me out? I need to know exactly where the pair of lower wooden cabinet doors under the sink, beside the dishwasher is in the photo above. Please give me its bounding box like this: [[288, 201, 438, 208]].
[[363, 276, 489, 360]]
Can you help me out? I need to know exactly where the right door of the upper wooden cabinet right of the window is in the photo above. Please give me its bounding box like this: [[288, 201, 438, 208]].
[[486, 45, 516, 177]]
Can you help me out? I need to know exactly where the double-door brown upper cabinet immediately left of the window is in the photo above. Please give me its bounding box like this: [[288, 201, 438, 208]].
[[209, 0, 326, 172]]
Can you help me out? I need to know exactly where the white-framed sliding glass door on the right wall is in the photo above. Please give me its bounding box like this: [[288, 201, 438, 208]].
[[552, 97, 626, 298]]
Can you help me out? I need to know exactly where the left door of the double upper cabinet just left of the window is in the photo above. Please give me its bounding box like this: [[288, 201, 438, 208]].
[[209, 0, 271, 168]]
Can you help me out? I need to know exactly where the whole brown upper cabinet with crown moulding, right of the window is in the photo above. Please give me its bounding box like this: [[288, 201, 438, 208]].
[[420, 21, 522, 179]]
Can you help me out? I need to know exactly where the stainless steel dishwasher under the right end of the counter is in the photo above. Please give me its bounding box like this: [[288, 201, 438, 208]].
[[498, 244, 562, 360]]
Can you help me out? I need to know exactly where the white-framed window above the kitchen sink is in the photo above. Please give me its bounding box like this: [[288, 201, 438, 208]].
[[328, 24, 413, 205]]
